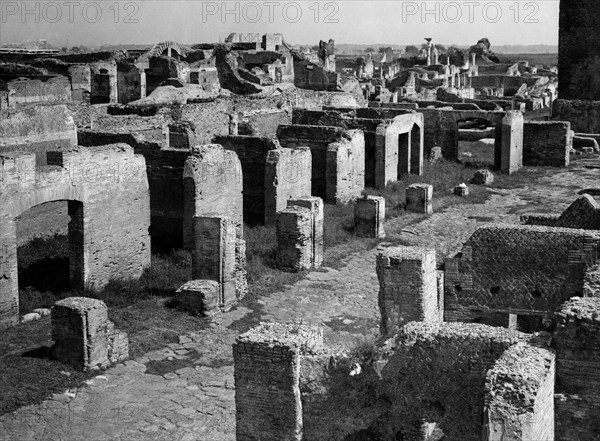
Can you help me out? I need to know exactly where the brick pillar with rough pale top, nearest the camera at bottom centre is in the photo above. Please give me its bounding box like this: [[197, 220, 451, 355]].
[[233, 323, 323, 441]]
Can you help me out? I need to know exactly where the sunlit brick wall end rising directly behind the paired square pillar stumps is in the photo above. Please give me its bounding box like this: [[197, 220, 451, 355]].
[[264, 147, 312, 225]]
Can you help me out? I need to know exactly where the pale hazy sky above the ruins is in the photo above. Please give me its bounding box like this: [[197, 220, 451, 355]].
[[0, 0, 559, 49]]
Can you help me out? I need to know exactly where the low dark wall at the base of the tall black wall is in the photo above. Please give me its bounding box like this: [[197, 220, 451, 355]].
[[552, 99, 600, 133]]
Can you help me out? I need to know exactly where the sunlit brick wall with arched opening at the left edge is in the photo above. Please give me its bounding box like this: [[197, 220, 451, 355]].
[[0, 144, 150, 325]]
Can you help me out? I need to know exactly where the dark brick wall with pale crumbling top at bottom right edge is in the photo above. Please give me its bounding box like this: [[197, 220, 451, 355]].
[[554, 297, 600, 441]]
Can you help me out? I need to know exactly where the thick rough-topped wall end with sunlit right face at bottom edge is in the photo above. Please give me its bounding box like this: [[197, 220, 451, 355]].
[[483, 343, 556, 441]]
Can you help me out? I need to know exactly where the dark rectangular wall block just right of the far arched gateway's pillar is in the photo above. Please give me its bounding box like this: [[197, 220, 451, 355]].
[[523, 121, 573, 167]]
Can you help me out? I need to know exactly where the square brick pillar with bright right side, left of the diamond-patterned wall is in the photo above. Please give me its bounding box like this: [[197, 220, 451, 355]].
[[377, 247, 442, 336]]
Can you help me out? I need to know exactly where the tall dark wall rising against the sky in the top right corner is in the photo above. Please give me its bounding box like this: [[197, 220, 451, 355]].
[[558, 0, 600, 100]]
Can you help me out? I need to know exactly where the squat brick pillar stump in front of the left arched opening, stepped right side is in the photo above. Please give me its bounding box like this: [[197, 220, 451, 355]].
[[52, 297, 129, 371]]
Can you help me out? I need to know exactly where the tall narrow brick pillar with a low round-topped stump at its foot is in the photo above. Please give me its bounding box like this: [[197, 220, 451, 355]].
[[192, 216, 237, 310]]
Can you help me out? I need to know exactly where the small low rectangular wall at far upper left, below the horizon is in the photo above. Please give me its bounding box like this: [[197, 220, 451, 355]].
[[7, 77, 71, 108]]
